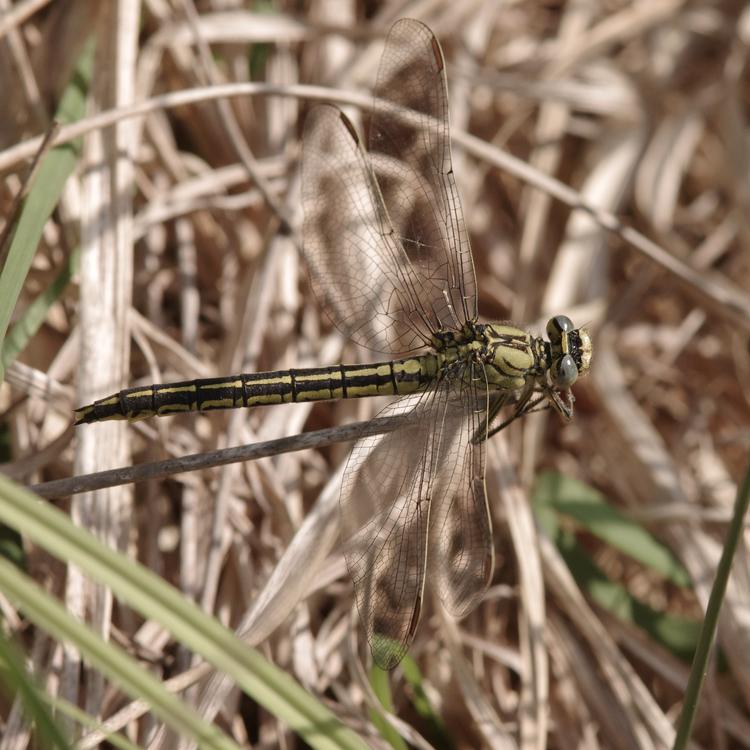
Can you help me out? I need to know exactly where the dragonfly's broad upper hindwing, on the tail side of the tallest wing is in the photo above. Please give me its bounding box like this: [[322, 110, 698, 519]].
[[302, 105, 433, 354]]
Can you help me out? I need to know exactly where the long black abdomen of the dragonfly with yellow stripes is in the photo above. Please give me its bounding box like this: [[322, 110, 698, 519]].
[[76, 354, 437, 424]]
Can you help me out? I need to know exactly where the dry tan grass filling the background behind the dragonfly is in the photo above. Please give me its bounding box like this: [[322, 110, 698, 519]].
[[0, 0, 750, 748]]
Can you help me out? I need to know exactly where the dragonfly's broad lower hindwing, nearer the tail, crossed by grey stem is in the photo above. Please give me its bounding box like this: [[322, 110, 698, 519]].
[[341, 386, 462, 669]]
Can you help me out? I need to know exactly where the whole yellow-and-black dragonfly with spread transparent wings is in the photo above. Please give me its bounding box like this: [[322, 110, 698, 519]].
[[76, 19, 592, 669]]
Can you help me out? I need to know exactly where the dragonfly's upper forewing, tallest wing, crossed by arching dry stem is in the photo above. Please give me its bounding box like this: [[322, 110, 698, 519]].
[[369, 19, 477, 328]]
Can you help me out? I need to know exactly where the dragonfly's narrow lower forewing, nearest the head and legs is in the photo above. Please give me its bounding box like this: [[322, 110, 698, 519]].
[[429, 365, 495, 617]]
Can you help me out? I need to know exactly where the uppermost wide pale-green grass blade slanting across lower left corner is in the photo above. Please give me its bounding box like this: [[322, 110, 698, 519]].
[[0, 475, 366, 748]]
